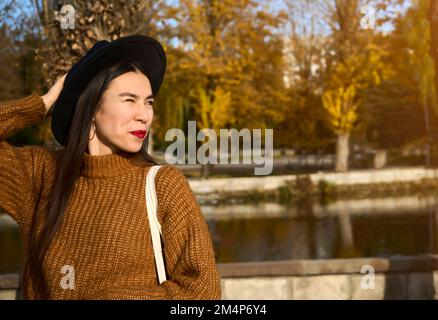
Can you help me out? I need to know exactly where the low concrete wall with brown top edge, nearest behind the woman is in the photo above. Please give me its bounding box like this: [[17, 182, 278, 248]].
[[0, 255, 438, 300]]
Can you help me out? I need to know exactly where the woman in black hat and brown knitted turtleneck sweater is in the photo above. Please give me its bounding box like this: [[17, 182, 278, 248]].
[[0, 36, 221, 299]]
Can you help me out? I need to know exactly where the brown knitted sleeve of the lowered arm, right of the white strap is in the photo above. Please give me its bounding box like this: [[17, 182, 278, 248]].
[[89, 165, 221, 300]]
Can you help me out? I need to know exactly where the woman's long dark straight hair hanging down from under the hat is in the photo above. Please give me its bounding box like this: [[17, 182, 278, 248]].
[[23, 61, 157, 299]]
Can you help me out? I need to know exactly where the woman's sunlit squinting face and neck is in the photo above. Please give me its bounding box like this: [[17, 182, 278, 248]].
[[88, 72, 154, 155]]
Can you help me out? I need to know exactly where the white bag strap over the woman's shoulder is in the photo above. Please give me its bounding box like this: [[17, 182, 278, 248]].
[[146, 166, 166, 284]]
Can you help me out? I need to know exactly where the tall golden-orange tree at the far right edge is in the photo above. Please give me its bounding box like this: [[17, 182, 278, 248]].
[[365, 0, 438, 165]]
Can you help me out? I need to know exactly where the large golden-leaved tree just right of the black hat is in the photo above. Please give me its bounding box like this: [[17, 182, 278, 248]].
[[171, 0, 288, 134]]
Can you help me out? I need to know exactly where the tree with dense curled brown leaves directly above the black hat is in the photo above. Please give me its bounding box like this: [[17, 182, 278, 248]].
[[34, 0, 169, 83]]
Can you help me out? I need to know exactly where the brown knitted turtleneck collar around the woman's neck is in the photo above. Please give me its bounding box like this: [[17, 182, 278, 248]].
[[82, 151, 135, 178]]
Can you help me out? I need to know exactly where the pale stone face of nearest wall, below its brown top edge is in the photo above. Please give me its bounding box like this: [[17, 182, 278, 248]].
[[221, 271, 438, 300]]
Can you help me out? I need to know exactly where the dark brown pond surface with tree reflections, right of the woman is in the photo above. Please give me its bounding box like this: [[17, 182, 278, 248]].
[[208, 213, 436, 262]]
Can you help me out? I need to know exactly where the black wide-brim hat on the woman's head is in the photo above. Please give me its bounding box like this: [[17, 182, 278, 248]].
[[51, 35, 167, 146]]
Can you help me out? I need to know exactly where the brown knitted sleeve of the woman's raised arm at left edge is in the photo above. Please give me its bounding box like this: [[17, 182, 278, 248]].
[[0, 93, 46, 225]]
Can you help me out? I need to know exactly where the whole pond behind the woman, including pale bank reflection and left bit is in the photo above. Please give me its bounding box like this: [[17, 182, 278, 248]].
[[0, 196, 438, 274]]
